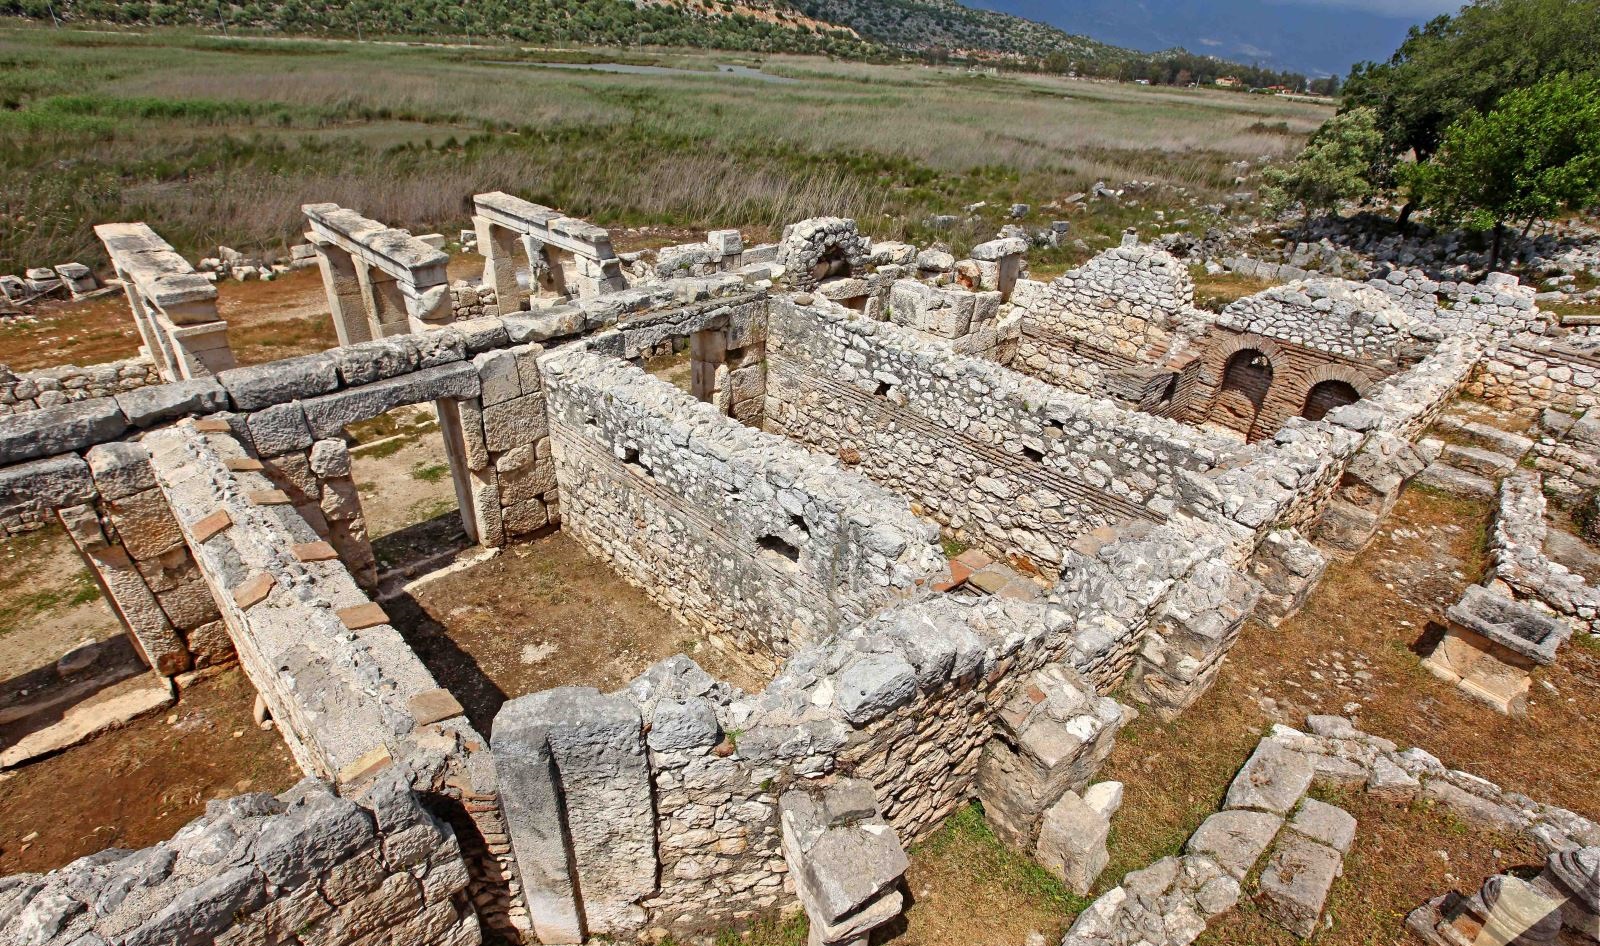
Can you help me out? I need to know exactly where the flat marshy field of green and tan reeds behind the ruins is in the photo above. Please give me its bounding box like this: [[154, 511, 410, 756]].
[[0, 26, 1325, 272]]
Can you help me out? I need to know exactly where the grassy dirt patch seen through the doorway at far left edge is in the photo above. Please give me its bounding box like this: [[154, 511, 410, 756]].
[[0, 525, 122, 682]]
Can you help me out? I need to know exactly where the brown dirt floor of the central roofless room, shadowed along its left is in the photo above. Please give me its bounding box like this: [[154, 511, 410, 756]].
[[384, 531, 762, 733]]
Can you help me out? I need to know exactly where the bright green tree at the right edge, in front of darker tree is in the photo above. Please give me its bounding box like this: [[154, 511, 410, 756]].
[[1402, 74, 1600, 269]]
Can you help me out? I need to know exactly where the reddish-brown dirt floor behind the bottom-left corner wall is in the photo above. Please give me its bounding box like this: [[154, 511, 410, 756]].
[[0, 669, 299, 876]]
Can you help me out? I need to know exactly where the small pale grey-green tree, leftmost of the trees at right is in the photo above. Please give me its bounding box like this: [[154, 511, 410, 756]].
[[1262, 109, 1384, 224]]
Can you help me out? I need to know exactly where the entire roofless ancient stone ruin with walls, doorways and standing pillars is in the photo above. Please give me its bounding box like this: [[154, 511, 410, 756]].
[[0, 200, 1600, 946]]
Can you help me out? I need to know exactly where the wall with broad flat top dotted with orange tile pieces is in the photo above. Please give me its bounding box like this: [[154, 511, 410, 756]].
[[146, 423, 525, 928]]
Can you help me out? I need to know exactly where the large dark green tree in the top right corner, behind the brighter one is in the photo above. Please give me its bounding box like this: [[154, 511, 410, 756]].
[[1344, 0, 1600, 226]]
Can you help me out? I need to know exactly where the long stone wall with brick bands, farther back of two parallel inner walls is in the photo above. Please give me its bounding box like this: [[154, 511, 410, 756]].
[[766, 299, 1230, 568]]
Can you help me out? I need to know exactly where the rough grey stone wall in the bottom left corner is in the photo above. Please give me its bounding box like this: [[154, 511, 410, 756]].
[[0, 778, 483, 946]]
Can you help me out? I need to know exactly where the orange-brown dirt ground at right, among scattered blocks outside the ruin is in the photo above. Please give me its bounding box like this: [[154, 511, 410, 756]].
[[1098, 487, 1600, 946]]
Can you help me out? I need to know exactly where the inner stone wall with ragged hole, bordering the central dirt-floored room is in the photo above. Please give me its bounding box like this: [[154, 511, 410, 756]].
[[541, 351, 947, 667]]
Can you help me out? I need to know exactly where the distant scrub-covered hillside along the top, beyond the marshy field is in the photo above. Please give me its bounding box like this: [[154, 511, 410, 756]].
[[9, 0, 1312, 85]]
